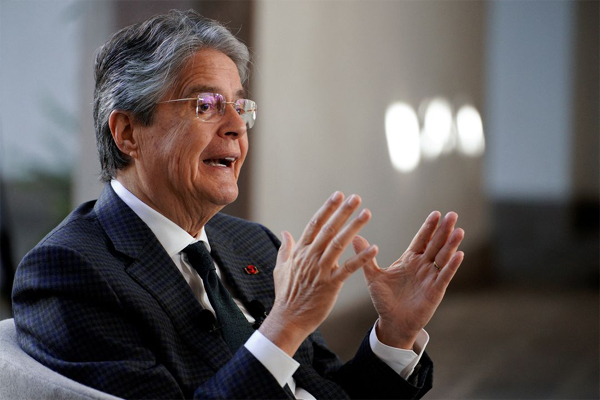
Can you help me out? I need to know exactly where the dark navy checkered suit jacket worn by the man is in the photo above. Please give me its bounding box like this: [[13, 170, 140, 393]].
[[13, 185, 432, 399]]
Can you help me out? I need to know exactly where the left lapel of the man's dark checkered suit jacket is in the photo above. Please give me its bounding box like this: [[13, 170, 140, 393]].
[[96, 185, 231, 371]]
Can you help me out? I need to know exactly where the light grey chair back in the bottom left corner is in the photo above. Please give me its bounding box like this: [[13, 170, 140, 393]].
[[0, 318, 118, 400]]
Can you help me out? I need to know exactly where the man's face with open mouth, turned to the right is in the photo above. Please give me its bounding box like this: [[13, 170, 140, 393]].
[[135, 49, 248, 216]]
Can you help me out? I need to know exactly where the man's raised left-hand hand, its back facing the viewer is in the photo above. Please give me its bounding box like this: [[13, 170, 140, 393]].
[[260, 192, 377, 356]]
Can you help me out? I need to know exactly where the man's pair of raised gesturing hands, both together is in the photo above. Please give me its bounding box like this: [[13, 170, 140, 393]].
[[260, 192, 464, 356]]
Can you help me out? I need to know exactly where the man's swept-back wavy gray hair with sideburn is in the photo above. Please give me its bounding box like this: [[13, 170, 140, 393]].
[[94, 10, 250, 182]]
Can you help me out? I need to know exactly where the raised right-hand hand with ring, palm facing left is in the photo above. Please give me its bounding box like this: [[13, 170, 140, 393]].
[[352, 211, 464, 349]]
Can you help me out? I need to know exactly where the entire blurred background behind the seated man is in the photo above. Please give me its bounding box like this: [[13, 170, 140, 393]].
[[0, 0, 600, 399]]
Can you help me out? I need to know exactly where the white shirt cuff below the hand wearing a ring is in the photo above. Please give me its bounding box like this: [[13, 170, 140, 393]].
[[369, 322, 429, 379]]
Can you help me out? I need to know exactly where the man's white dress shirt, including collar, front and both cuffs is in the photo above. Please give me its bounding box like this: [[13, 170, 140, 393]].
[[111, 179, 429, 399]]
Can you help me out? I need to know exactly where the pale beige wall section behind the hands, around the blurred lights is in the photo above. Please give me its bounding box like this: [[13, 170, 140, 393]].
[[251, 1, 488, 314]]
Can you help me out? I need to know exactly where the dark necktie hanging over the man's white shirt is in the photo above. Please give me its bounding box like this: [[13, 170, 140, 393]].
[[183, 242, 254, 353]]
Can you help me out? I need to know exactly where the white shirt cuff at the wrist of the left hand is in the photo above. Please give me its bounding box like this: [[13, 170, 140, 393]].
[[244, 331, 300, 387]]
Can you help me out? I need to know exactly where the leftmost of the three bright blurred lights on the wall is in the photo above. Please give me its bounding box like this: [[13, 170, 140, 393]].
[[385, 103, 421, 172]]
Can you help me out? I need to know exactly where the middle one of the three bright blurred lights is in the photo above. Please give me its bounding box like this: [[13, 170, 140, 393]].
[[421, 97, 454, 159]]
